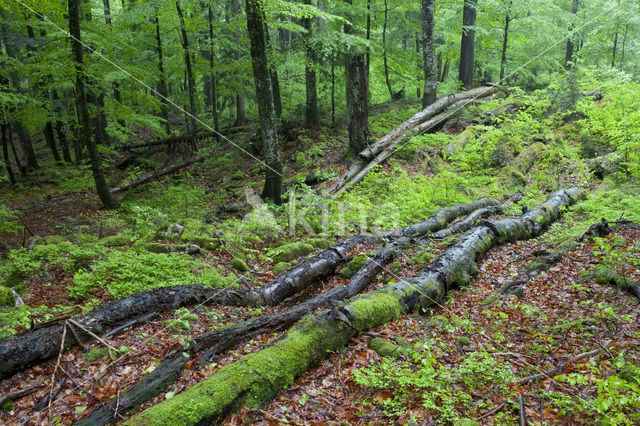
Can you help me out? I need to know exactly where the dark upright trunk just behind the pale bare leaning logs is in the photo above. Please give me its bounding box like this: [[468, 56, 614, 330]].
[[344, 0, 369, 158]]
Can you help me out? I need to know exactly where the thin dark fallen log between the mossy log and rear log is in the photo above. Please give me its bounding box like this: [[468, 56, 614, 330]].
[[72, 199, 497, 425]]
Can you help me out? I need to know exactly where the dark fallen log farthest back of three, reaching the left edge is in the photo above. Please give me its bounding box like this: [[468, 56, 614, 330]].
[[0, 200, 497, 377]]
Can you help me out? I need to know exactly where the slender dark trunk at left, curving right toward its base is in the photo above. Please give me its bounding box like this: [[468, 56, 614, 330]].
[[69, 0, 118, 209]]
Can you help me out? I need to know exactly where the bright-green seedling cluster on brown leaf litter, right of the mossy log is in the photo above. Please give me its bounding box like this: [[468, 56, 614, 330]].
[[353, 341, 514, 423]]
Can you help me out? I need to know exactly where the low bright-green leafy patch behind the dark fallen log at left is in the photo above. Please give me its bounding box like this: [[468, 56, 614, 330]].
[[69, 250, 237, 299]]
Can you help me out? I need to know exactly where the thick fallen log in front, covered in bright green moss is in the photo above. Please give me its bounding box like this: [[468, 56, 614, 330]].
[[125, 188, 581, 425]]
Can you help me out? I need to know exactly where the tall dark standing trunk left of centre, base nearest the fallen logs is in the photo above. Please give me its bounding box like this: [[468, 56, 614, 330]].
[[246, 0, 282, 204]]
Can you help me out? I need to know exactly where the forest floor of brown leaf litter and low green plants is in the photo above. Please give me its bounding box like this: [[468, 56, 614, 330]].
[[0, 93, 640, 424]]
